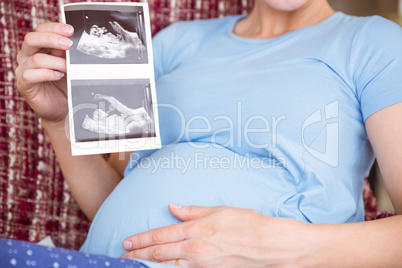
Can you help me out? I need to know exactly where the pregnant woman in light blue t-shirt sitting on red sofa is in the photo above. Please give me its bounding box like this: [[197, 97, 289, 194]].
[[17, 0, 402, 267]]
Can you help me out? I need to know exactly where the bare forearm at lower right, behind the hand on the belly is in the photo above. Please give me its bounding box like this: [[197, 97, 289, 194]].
[[307, 215, 402, 267]]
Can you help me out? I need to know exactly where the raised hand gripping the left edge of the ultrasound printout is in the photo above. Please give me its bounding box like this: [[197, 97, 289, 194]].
[[16, 23, 74, 123]]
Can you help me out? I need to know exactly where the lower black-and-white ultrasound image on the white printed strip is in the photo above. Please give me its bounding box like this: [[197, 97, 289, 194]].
[[71, 79, 155, 142]]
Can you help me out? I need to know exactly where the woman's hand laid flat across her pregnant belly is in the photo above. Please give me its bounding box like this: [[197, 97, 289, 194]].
[[121, 204, 314, 267]]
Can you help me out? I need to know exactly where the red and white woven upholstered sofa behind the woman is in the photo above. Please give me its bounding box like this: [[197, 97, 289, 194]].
[[0, 0, 394, 249]]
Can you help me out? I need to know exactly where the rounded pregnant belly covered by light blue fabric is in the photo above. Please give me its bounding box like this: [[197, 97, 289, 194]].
[[81, 143, 293, 257]]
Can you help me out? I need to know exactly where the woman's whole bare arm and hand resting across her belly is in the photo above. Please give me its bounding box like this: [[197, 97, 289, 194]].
[[119, 103, 402, 267]]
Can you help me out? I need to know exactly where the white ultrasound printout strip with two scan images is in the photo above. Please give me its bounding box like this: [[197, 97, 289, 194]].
[[62, 3, 161, 155]]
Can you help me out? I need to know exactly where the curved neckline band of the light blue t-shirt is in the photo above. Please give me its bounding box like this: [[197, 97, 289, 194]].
[[229, 11, 343, 43]]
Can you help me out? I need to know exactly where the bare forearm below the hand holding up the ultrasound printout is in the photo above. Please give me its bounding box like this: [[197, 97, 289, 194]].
[[42, 121, 122, 220]]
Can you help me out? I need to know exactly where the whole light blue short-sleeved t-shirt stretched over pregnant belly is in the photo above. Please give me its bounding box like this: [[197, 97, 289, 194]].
[[82, 12, 402, 257]]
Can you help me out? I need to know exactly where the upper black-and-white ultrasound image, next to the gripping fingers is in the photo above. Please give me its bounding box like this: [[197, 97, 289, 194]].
[[64, 5, 148, 64]]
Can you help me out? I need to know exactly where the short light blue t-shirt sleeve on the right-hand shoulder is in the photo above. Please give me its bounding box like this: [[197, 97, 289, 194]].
[[350, 16, 402, 120]]
